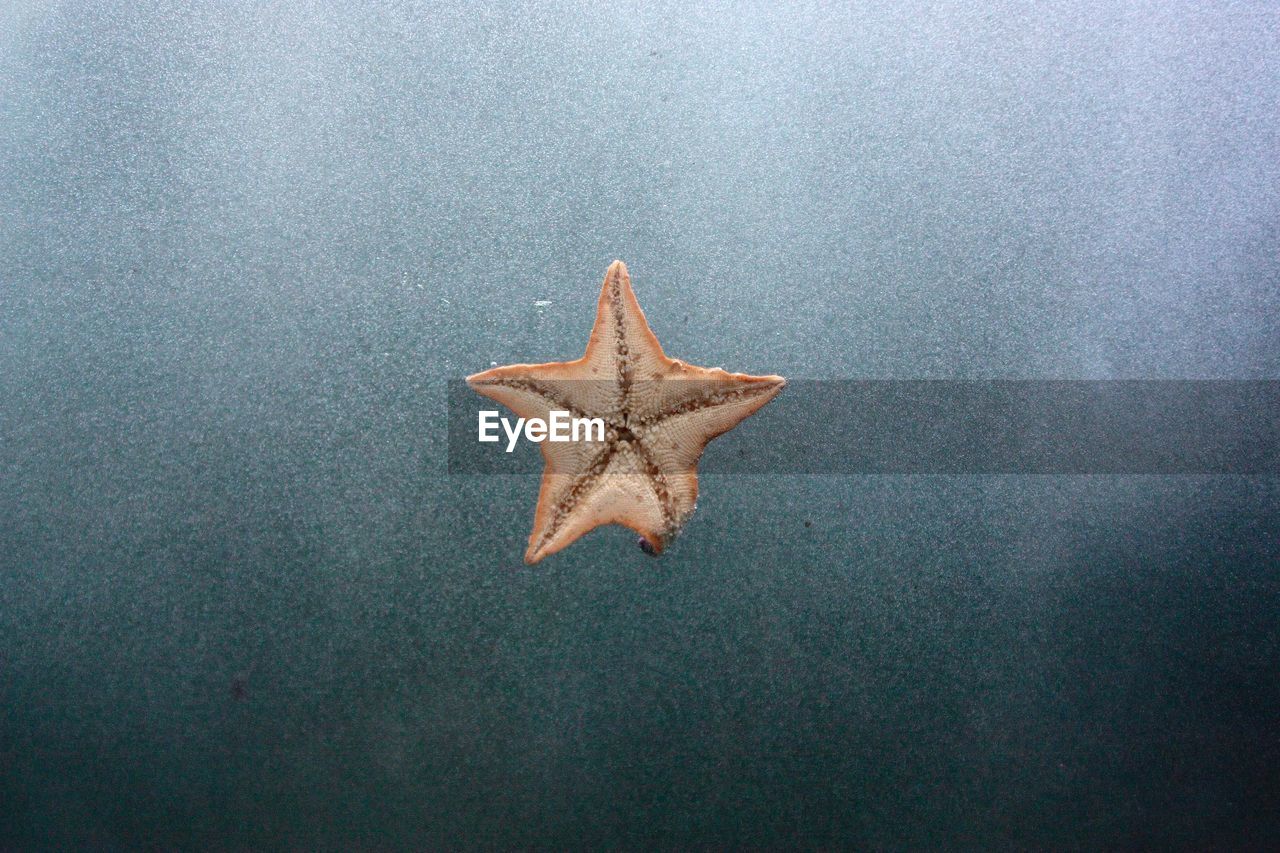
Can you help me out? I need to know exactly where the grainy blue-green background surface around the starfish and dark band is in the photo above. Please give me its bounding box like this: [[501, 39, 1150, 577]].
[[0, 0, 1280, 849]]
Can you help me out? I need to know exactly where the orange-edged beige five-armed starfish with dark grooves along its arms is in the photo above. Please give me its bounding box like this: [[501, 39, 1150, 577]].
[[467, 260, 786, 564]]
